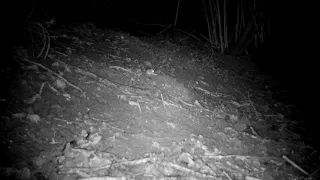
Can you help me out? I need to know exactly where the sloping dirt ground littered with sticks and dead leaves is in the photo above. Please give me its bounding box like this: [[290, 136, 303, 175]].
[[0, 25, 319, 180]]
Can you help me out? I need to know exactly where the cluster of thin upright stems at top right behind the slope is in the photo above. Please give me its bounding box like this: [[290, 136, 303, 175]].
[[203, 0, 270, 55]]
